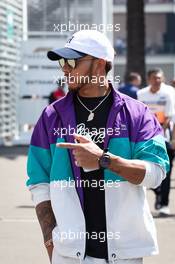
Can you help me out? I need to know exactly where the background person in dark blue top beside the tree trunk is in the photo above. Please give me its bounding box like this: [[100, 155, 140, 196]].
[[118, 72, 142, 99]]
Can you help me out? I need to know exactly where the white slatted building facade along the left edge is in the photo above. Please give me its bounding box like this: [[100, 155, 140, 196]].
[[0, 0, 22, 143]]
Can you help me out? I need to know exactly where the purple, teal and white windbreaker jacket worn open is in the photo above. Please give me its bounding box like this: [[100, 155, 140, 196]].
[[27, 88, 169, 260]]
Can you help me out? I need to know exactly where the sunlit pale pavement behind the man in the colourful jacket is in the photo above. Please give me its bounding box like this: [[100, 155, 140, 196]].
[[0, 147, 175, 264]]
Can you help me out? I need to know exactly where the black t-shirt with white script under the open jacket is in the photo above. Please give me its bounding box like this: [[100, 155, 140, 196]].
[[74, 89, 113, 259]]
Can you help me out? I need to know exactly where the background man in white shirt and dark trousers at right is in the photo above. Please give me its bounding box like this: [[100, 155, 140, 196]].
[[138, 68, 174, 215]]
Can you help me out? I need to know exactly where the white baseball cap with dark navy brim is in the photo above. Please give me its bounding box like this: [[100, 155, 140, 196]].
[[47, 30, 115, 62]]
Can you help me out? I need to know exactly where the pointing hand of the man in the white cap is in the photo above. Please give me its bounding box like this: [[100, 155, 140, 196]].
[[56, 134, 103, 169]]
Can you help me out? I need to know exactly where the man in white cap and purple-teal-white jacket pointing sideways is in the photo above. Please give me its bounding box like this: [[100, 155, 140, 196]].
[[27, 30, 168, 264]]
